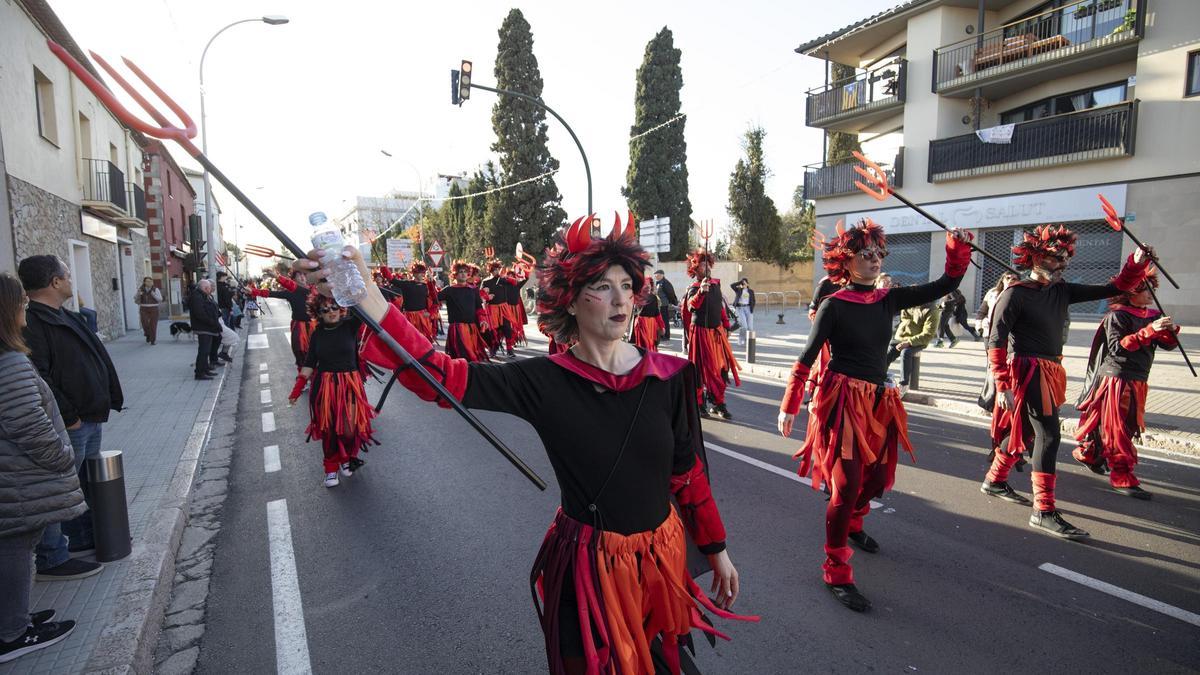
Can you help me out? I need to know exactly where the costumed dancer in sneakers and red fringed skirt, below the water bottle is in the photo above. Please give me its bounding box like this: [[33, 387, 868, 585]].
[[288, 293, 376, 488]]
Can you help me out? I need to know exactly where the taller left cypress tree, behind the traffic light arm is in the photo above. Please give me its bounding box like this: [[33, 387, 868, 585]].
[[481, 8, 566, 255]]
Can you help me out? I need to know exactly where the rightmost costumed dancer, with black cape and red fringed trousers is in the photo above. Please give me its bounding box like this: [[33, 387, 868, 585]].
[[1072, 271, 1180, 500]]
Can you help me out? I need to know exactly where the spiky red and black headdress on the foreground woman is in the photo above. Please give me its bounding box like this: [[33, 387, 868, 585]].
[[538, 211, 650, 345]]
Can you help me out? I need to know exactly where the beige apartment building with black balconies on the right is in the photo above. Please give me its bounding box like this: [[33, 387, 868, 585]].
[[797, 0, 1200, 322]]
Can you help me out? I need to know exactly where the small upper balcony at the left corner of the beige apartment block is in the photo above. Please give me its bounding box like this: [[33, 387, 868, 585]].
[[804, 59, 908, 133]]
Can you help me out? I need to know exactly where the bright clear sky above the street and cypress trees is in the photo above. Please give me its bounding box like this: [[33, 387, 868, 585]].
[[50, 0, 895, 273]]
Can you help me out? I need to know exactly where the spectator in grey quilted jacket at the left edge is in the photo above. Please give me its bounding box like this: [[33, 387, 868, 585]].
[[0, 274, 85, 663]]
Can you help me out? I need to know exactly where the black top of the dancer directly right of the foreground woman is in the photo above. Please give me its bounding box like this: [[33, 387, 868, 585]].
[[799, 274, 962, 384]]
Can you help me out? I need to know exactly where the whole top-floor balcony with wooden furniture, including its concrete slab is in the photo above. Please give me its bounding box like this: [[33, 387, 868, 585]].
[[932, 0, 1146, 100]]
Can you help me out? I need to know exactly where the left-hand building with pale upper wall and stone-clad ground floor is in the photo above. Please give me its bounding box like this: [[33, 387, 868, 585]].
[[0, 0, 149, 339]]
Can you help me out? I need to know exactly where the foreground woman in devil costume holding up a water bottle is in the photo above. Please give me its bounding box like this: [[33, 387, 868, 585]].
[[296, 212, 752, 675]]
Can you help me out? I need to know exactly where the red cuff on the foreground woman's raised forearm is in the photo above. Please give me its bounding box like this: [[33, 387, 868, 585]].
[[360, 306, 468, 407]]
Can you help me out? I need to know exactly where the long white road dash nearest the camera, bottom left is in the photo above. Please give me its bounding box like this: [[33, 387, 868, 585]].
[[266, 500, 312, 675]]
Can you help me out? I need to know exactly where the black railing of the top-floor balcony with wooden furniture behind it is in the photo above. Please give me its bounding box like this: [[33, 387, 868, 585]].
[[934, 0, 1145, 92]]
